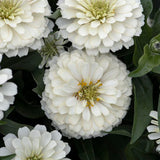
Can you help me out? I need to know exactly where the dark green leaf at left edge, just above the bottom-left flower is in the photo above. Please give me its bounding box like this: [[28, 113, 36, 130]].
[[0, 119, 32, 135]]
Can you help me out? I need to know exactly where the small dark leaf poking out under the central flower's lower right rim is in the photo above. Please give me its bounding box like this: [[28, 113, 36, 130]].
[[105, 125, 131, 137]]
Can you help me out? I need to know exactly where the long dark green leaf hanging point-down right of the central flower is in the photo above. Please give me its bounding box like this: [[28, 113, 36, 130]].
[[131, 76, 153, 144]]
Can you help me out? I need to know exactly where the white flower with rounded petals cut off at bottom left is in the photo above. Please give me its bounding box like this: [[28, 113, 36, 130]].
[[0, 125, 70, 160]]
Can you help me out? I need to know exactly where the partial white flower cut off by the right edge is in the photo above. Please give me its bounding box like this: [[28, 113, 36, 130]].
[[147, 111, 160, 153]]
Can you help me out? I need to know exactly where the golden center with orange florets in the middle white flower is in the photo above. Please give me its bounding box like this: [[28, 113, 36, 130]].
[[75, 80, 102, 108]]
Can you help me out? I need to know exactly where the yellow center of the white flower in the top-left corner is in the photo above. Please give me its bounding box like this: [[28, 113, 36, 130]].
[[0, 0, 23, 20]]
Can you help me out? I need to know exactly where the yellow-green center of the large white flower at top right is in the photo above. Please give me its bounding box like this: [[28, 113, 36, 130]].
[[80, 0, 117, 23]]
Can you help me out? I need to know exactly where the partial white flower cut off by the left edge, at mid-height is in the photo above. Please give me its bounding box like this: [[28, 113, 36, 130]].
[[0, 55, 17, 120]]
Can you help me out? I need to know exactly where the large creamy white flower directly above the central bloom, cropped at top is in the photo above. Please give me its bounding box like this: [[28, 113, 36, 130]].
[[56, 0, 144, 55]]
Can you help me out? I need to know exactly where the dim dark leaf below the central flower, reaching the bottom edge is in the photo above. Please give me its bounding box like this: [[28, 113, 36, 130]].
[[75, 140, 96, 160]]
